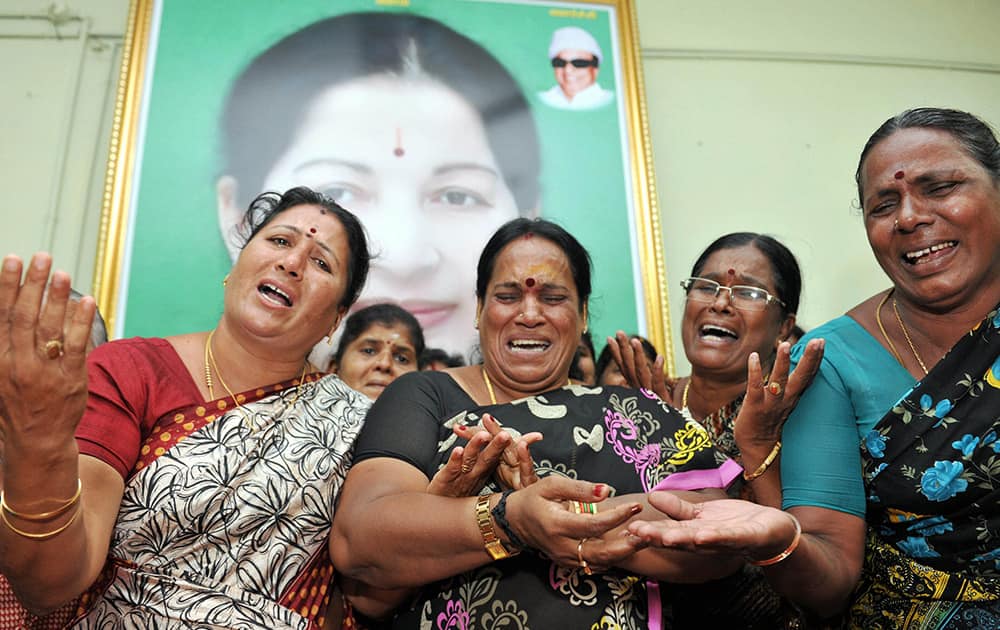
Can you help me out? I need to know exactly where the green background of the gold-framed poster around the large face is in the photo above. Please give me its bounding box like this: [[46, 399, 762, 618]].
[[125, 0, 642, 358]]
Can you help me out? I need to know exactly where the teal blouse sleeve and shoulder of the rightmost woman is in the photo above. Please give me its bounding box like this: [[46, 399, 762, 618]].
[[781, 315, 914, 518]]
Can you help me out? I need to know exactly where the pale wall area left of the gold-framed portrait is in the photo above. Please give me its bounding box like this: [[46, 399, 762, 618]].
[[0, 0, 128, 292]]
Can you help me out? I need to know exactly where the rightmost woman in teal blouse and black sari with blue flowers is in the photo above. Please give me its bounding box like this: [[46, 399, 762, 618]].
[[782, 108, 1000, 629]]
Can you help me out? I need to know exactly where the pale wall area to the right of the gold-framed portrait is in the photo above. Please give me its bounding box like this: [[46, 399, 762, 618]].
[[638, 0, 1000, 374]]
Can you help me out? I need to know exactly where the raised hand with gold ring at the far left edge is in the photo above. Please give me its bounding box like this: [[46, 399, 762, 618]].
[[0, 253, 97, 449]]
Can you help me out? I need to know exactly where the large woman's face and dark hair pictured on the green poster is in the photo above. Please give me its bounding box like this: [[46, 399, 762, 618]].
[[217, 12, 540, 354]]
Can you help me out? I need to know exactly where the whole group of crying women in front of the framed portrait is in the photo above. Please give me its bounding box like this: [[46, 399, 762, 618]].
[[0, 95, 1000, 630]]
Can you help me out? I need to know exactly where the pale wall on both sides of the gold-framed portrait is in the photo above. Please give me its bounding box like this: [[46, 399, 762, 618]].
[[0, 0, 1000, 373]]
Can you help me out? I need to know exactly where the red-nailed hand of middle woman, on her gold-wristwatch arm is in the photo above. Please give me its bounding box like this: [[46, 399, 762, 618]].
[[507, 475, 646, 570]]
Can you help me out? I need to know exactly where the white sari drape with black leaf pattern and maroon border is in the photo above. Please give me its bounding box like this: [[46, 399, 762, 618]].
[[69, 376, 370, 630]]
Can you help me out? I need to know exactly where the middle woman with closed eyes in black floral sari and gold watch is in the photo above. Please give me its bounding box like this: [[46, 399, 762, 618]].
[[333, 219, 820, 629]]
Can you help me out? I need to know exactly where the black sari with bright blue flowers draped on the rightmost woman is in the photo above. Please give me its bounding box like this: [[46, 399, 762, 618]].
[[850, 309, 1000, 630]]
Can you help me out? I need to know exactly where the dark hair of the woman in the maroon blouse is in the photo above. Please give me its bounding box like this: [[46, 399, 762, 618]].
[[239, 186, 371, 308]]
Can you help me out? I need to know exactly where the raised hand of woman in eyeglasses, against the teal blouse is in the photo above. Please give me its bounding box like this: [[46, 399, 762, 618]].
[[733, 339, 824, 450]]
